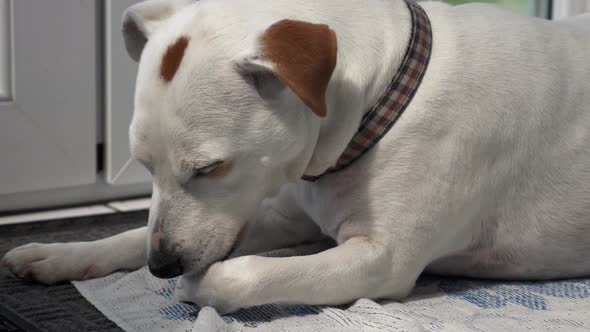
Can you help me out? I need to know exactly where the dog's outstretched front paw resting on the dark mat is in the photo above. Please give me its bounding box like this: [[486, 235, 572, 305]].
[[0, 243, 100, 284]]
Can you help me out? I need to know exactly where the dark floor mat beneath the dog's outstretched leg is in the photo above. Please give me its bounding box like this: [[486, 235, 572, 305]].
[[0, 211, 147, 332]]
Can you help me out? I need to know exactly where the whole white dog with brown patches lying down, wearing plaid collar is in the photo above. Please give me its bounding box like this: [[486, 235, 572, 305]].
[[3, 0, 590, 313]]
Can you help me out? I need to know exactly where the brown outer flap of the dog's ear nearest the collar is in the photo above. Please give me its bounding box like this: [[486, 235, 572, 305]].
[[261, 20, 337, 117]]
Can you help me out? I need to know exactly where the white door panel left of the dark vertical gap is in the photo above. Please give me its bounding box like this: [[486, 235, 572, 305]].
[[0, 0, 98, 195]]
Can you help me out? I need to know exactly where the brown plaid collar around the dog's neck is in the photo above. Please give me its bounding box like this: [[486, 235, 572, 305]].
[[302, 0, 432, 182]]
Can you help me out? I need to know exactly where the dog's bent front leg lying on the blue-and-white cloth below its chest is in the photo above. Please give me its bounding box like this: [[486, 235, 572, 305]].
[[177, 237, 420, 313]]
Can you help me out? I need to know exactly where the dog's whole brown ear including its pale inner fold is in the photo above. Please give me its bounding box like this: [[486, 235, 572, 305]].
[[238, 20, 337, 117]]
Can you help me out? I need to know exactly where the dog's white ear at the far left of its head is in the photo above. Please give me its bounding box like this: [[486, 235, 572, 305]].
[[122, 0, 195, 61]]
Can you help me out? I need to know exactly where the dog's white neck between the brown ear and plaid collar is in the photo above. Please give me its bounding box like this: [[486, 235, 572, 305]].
[[305, 0, 411, 176]]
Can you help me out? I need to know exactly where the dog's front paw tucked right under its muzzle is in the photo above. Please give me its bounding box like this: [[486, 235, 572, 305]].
[[175, 256, 255, 315]]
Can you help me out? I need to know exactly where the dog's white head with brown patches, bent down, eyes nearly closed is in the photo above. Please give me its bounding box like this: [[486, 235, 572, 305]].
[[123, 0, 336, 277]]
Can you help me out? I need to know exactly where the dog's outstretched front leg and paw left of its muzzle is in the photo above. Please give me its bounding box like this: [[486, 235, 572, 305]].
[[0, 227, 147, 284]]
